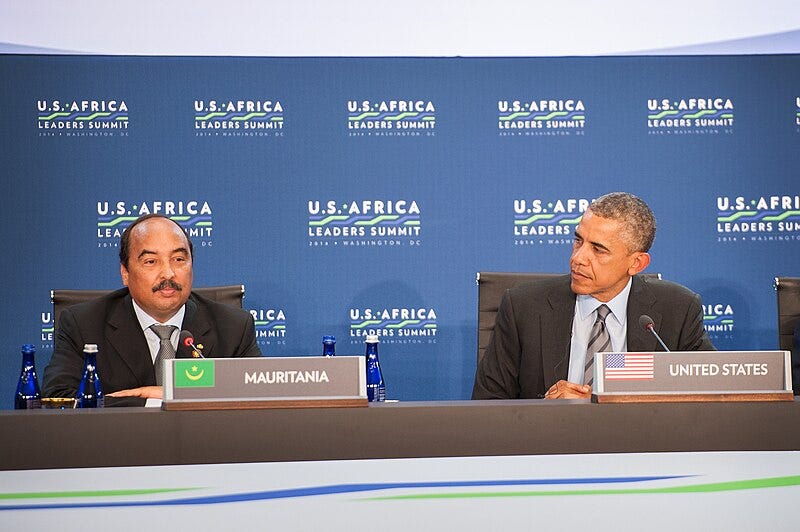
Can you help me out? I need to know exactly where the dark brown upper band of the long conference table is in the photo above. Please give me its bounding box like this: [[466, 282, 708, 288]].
[[0, 400, 800, 470]]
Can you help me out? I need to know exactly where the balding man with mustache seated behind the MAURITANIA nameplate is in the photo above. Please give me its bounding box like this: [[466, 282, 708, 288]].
[[42, 214, 261, 406]]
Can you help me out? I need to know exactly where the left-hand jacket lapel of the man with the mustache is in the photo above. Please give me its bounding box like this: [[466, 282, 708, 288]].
[[106, 295, 155, 386]]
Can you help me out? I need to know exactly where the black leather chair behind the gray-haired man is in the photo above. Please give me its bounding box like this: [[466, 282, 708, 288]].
[[476, 272, 661, 361]]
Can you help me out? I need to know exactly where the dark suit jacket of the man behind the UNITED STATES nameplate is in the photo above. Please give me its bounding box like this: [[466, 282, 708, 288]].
[[472, 275, 714, 399]]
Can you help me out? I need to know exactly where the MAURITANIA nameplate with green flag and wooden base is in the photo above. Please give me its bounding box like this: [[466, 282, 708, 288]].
[[162, 356, 367, 410]]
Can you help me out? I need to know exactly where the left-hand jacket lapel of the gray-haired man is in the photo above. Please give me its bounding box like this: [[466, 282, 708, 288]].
[[540, 276, 575, 382]]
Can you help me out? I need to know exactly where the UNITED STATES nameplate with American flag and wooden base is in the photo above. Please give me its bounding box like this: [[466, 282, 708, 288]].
[[592, 351, 794, 403]]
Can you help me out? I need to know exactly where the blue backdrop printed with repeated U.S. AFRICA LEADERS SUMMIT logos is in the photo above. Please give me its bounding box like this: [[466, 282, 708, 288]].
[[0, 55, 800, 408]]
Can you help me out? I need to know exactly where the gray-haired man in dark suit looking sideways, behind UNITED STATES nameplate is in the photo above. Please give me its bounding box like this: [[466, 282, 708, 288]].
[[472, 192, 714, 399]]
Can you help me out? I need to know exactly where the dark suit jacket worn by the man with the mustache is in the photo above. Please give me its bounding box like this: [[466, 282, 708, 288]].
[[42, 288, 261, 405]]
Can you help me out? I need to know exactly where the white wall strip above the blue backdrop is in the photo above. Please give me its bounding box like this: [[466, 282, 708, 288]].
[[0, 0, 800, 56]]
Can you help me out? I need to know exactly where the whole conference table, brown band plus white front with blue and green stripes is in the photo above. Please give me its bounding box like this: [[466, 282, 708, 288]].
[[0, 400, 800, 530]]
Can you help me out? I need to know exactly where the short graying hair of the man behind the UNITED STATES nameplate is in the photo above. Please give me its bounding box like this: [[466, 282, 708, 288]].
[[589, 192, 656, 252]]
